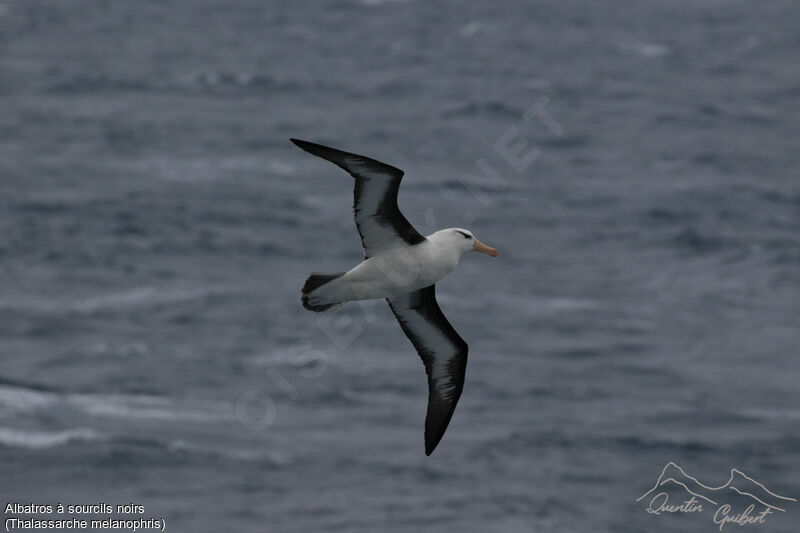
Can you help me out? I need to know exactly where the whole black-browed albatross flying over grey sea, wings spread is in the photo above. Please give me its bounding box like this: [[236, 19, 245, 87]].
[[290, 139, 497, 455]]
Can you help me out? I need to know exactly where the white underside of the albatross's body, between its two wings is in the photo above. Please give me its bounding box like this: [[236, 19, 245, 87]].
[[309, 240, 461, 305]]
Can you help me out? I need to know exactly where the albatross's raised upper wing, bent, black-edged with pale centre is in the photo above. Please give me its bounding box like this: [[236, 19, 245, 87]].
[[290, 139, 425, 258]]
